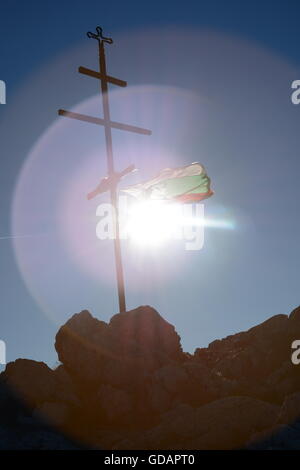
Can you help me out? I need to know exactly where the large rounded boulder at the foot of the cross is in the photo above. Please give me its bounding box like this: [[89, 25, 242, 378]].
[[55, 306, 183, 389]]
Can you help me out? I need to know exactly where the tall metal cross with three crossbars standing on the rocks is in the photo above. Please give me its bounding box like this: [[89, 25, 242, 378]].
[[58, 26, 152, 312]]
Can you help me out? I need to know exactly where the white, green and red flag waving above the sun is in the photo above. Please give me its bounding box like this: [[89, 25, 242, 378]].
[[122, 162, 214, 203]]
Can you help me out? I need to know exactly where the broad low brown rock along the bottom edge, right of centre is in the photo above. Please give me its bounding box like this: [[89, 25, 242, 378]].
[[135, 397, 278, 449]]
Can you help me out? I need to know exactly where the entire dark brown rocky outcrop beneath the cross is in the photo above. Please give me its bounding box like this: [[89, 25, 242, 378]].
[[0, 306, 300, 449]]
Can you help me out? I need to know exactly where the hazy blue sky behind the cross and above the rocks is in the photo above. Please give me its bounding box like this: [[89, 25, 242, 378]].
[[0, 0, 300, 365]]
